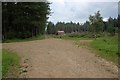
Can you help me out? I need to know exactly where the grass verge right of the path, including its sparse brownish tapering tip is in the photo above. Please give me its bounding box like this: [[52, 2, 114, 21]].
[[75, 36, 118, 65]]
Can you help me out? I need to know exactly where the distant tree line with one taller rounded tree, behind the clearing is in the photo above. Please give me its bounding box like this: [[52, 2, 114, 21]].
[[47, 11, 118, 35]]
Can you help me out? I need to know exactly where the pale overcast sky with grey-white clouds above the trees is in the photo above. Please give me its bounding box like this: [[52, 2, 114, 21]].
[[48, 0, 119, 23]]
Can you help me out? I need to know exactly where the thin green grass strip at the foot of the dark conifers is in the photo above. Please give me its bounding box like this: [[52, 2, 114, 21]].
[[4, 35, 45, 43]]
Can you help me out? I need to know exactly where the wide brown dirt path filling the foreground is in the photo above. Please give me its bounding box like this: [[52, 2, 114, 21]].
[[3, 38, 118, 78]]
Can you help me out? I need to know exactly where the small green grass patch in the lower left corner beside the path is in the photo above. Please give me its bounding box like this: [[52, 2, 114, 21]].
[[2, 49, 20, 77]]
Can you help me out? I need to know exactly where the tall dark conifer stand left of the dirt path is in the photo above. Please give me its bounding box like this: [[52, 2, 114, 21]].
[[2, 2, 50, 41]]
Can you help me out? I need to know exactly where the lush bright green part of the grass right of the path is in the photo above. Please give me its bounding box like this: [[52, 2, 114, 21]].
[[90, 36, 118, 64]]
